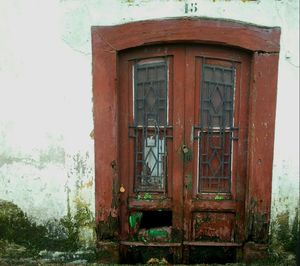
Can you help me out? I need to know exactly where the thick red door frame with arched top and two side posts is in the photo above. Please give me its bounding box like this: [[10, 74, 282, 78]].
[[92, 18, 280, 260]]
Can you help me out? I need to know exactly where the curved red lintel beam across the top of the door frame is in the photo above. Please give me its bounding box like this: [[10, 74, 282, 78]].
[[92, 18, 280, 53]]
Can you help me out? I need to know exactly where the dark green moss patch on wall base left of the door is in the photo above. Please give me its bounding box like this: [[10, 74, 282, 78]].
[[0, 200, 94, 255]]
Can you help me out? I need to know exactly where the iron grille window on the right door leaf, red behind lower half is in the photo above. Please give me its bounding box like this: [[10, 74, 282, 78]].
[[195, 64, 238, 193]]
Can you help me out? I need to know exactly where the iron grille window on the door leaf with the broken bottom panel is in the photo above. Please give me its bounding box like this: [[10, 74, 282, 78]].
[[130, 59, 172, 192]]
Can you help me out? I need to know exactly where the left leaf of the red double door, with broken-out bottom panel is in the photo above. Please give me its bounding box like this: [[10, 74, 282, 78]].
[[119, 45, 185, 242]]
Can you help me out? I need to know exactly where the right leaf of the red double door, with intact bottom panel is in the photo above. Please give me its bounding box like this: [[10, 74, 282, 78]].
[[184, 46, 250, 245]]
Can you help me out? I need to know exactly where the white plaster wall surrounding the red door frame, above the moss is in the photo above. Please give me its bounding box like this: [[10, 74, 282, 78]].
[[0, 0, 299, 241]]
